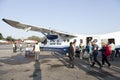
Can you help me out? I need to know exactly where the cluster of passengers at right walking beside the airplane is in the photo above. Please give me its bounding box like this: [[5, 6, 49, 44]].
[[69, 40, 115, 69]]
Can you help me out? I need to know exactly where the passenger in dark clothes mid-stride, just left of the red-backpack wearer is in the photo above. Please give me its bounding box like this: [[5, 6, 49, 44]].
[[91, 40, 102, 69]]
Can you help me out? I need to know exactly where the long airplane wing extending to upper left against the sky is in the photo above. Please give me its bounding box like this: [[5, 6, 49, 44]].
[[2, 19, 76, 37]]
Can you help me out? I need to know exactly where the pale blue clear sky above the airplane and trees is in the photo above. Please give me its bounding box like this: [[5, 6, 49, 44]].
[[0, 0, 120, 38]]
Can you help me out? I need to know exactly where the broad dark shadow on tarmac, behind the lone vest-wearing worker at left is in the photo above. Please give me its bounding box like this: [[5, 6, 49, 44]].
[[0, 53, 61, 66]]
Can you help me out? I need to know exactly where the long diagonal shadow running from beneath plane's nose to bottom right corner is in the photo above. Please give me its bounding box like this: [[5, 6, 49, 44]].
[[53, 53, 120, 80]]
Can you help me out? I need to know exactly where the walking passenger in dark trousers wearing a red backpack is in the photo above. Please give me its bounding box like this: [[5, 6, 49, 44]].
[[102, 40, 112, 67]]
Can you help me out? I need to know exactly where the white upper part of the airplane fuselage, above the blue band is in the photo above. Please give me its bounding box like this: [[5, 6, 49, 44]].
[[40, 32, 120, 48]]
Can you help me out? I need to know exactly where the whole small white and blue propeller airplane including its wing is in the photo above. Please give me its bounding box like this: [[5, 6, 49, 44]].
[[2, 19, 120, 53]]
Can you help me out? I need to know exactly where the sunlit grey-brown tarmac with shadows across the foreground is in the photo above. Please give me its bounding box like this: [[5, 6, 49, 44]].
[[0, 45, 120, 80]]
